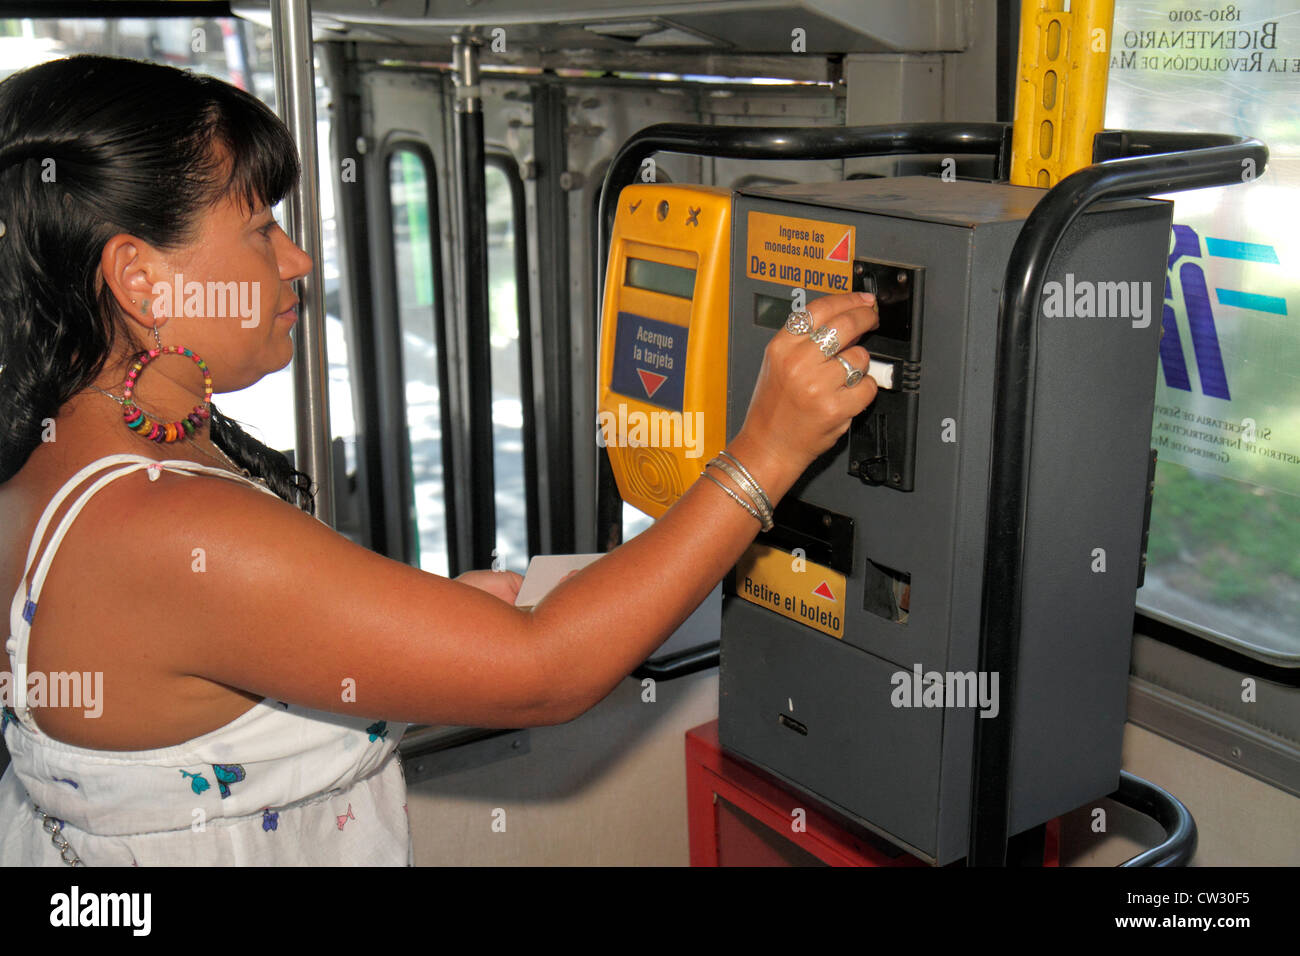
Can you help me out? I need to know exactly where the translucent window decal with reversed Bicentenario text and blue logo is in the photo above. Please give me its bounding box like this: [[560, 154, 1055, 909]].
[[1106, 0, 1300, 494]]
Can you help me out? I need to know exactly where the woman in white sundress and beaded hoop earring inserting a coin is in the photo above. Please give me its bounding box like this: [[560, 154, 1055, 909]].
[[0, 56, 878, 865]]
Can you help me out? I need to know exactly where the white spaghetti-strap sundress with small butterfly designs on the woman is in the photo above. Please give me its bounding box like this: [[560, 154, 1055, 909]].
[[0, 455, 413, 866]]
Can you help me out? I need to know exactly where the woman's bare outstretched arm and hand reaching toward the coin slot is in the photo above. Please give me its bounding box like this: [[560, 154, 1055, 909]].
[[137, 295, 878, 727]]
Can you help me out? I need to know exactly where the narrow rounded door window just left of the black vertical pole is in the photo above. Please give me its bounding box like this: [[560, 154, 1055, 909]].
[[389, 147, 449, 575]]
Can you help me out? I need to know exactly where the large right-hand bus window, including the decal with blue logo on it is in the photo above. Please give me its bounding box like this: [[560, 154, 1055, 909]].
[[1106, 0, 1300, 665]]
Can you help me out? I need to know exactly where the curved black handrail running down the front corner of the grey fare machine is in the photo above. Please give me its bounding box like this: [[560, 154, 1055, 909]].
[[967, 131, 1269, 866]]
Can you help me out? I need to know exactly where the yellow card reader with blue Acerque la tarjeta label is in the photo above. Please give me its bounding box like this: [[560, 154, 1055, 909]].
[[597, 183, 732, 518]]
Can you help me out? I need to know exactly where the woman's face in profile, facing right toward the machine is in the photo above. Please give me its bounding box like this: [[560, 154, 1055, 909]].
[[150, 196, 312, 392]]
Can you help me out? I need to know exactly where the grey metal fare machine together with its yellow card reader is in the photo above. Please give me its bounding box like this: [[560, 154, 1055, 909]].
[[599, 177, 1173, 864]]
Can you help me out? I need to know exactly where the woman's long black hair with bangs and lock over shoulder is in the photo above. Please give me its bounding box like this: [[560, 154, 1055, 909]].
[[0, 56, 315, 512]]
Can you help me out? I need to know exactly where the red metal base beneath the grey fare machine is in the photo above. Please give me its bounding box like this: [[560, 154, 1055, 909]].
[[686, 721, 1061, 866]]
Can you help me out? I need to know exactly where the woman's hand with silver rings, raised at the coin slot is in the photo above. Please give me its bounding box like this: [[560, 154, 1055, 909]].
[[731, 293, 880, 503]]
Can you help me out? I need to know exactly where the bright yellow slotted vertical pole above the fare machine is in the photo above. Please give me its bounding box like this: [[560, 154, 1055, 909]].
[[1011, 0, 1115, 189]]
